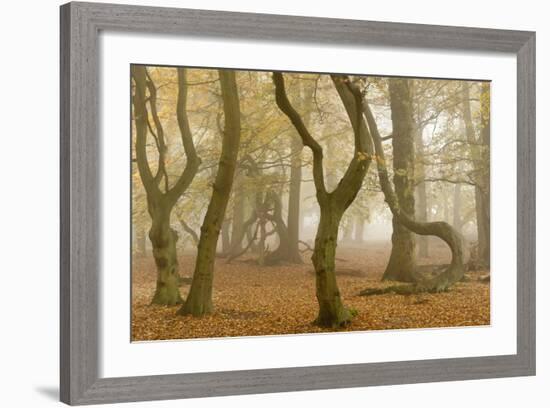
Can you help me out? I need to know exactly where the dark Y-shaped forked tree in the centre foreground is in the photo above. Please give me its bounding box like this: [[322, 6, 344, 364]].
[[273, 72, 373, 328]]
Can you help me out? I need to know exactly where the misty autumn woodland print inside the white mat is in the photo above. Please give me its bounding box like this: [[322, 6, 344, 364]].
[[130, 65, 490, 341]]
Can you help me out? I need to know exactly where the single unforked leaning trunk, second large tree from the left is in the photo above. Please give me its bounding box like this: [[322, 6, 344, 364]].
[[178, 70, 241, 316]]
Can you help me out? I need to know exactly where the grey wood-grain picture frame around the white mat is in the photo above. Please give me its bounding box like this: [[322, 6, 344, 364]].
[[60, 3, 535, 405]]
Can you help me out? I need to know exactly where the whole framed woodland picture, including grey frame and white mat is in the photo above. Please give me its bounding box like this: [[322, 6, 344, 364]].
[[60, 3, 535, 405]]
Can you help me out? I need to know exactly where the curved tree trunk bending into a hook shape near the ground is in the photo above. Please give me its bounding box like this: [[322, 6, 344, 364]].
[[363, 96, 464, 292]]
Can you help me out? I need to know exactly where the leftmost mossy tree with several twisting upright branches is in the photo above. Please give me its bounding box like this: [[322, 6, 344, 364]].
[[131, 65, 200, 305]]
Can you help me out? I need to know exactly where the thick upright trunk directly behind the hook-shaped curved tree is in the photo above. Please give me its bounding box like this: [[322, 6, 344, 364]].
[[382, 79, 416, 282]]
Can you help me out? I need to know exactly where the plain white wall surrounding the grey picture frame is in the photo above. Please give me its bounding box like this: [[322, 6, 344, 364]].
[[0, 0, 550, 408]]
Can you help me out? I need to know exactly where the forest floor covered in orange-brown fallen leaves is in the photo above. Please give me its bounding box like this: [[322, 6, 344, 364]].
[[132, 243, 490, 341]]
